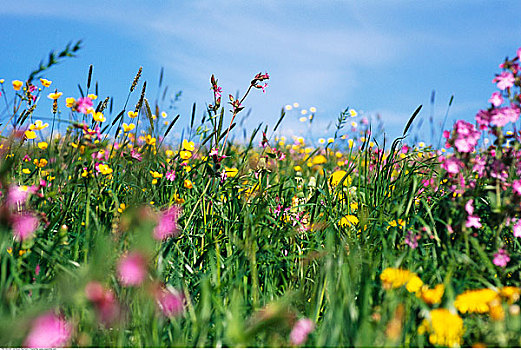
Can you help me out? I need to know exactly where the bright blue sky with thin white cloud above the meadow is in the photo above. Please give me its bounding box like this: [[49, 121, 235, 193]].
[[0, 0, 521, 141]]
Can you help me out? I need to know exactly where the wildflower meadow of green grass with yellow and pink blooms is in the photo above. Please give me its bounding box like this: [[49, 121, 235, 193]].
[[0, 46, 521, 347]]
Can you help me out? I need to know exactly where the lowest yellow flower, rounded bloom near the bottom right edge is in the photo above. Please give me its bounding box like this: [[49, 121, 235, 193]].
[[418, 309, 464, 347]]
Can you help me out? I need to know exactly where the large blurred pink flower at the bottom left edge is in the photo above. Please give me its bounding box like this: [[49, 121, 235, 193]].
[[23, 312, 72, 348]]
